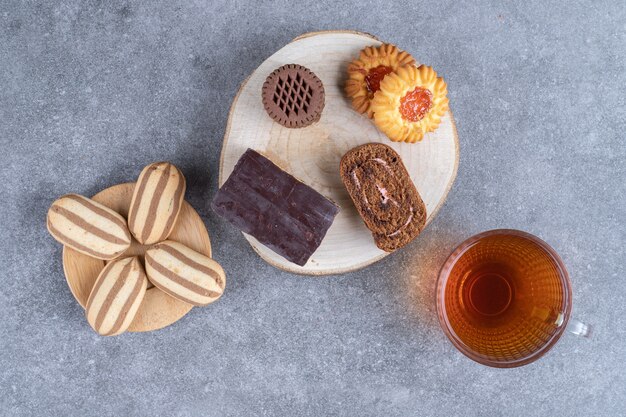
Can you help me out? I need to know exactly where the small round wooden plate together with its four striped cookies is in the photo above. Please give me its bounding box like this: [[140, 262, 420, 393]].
[[47, 162, 226, 336]]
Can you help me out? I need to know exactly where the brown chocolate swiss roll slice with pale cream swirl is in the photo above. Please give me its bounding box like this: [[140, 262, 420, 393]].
[[340, 143, 426, 252]]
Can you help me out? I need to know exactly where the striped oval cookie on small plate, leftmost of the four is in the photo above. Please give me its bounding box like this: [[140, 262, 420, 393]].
[[47, 194, 131, 259]]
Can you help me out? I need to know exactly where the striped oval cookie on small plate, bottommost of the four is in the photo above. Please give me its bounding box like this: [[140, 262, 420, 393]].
[[85, 256, 148, 336]]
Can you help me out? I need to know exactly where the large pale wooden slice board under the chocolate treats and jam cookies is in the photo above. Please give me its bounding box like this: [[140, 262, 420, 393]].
[[219, 31, 459, 275]]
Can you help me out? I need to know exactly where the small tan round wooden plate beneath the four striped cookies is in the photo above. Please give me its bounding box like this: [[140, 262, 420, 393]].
[[63, 183, 211, 332]]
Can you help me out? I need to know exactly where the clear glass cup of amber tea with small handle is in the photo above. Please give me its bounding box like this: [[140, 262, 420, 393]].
[[437, 229, 590, 368]]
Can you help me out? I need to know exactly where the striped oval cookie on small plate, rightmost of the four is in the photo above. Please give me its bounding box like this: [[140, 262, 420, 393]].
[[146, 240, 226, 306]]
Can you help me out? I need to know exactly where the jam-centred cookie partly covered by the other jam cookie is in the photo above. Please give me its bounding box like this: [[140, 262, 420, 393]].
[[345, 43, 415, 118]]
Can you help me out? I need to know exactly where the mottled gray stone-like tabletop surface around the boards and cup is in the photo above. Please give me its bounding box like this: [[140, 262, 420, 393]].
[[0, 0, 626, 416]]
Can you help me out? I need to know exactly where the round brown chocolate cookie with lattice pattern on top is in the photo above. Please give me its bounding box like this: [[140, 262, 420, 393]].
[[262, 64, 325, 128]]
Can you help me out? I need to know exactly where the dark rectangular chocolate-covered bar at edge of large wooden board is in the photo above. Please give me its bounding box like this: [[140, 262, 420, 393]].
[[212, 149, 339, 266]]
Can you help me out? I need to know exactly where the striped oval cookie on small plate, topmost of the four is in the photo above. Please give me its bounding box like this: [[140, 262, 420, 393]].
[[128, 162, 186, 245]]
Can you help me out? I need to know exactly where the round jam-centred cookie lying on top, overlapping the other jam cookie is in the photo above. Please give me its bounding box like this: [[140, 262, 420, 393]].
[[371, 65, 448, 143]]
